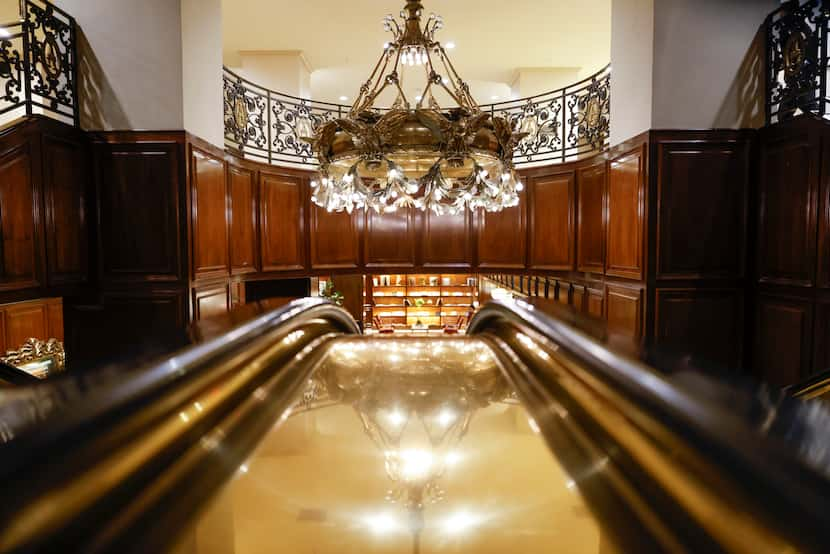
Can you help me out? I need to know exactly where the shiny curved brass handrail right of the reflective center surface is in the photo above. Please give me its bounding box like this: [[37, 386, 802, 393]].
[[468, 301, 830, 552]]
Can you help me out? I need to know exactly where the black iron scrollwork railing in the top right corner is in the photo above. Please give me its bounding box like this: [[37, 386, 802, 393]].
[[766, 0, 828, 123]]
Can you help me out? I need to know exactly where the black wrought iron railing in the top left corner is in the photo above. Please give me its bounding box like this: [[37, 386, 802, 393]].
[[0, 0, 79, 125]]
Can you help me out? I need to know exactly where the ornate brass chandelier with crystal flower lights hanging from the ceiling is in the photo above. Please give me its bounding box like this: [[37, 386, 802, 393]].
[[296, 0, 525, 215]]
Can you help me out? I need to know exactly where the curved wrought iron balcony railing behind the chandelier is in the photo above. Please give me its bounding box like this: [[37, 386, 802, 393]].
[[224, 66, 611, 166]]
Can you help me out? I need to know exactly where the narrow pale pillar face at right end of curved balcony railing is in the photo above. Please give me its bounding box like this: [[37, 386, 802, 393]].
[[611, 0, 652, 144]]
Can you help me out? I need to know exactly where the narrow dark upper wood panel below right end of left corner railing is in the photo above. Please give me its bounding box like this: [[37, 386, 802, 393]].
[[43, 135, 89, 285]]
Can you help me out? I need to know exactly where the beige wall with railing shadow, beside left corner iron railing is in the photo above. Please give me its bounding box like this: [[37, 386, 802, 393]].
[[56, 0, 184, 130]]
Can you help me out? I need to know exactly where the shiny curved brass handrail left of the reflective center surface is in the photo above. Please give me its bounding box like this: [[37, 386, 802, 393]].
[[0, 298, 360, 552]]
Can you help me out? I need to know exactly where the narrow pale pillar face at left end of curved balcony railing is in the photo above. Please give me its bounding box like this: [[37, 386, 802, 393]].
[[181, 0, 224, 146]]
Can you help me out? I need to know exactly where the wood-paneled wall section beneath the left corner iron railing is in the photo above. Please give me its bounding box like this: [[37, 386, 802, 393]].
[[0, 116, 94, 357]]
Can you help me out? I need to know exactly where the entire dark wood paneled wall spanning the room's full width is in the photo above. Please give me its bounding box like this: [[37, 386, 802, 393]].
[[0, 117, 748, 382]]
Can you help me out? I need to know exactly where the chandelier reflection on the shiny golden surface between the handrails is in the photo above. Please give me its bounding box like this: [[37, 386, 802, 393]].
[[304, 339, 513, 552]]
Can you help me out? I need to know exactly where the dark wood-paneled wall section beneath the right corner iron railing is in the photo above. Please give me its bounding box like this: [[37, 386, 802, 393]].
[[752, 116, 830, 385]]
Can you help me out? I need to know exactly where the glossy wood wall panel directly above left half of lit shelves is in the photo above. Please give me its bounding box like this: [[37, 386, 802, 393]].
[[363, 208, 418, 268]]
